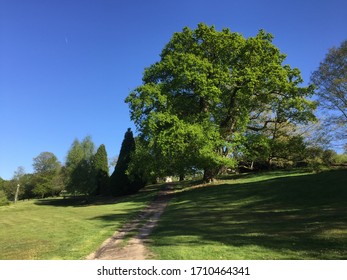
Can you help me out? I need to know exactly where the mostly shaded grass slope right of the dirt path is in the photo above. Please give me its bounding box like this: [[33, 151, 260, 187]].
[[150, 170, 347, 260]]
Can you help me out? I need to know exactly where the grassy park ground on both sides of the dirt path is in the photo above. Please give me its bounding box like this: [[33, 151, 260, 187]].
[[0, 167, 347, 260]]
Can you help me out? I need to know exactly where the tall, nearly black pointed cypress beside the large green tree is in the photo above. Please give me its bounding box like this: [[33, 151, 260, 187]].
[[110, 128, 144, 196]]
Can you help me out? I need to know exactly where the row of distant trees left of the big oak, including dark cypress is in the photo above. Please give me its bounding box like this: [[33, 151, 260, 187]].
[[0, 128, 146, 205]]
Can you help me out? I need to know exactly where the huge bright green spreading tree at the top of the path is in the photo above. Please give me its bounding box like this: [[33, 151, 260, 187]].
[[126, 24, 315, 181]]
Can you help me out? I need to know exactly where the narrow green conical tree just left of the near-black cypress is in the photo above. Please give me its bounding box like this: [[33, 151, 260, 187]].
[[93, 144, 110, 195]]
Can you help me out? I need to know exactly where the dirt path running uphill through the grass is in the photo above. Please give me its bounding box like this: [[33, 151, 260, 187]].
[[87, 186, 173, 260]]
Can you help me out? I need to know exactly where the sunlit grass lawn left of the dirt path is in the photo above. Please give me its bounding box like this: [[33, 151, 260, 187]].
[[0, 187, 157, 260]]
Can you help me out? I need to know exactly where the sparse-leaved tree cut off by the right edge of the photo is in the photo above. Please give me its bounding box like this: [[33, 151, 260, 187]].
[[311, 40, 347, 140]]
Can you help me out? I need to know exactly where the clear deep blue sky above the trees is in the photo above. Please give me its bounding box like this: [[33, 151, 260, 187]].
[[0, 0, 347, 179]]
